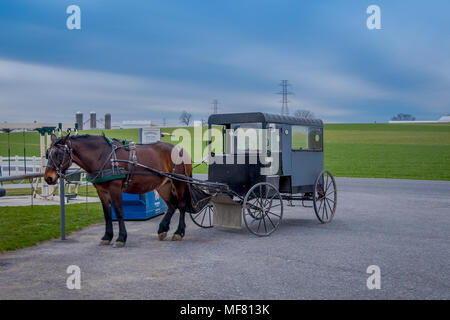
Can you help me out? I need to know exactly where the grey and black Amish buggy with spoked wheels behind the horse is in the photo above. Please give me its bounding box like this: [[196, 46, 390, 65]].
[[191, 112, 337, 236]]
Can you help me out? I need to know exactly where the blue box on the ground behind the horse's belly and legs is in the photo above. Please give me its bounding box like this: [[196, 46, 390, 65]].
[[111, 191, 167, 221]]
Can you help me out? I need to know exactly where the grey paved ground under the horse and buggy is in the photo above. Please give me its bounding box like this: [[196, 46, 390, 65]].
[[0, 178, 450, 299]]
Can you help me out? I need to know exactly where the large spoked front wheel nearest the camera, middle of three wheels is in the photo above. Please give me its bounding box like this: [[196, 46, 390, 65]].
[[242, 182, 283, 236]]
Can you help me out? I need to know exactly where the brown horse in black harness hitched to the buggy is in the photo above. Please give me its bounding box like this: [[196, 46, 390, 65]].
[[44, 134, 192, 247]]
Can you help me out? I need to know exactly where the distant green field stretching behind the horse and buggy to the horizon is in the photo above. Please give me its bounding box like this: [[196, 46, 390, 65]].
[[0, 123, 450, 180]]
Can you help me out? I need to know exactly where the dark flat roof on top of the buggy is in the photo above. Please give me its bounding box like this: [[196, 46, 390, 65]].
[[208, 112, 323, 127]]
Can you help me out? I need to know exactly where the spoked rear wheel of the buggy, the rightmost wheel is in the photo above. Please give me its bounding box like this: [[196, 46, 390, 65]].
[[313, 170, 337, 223]]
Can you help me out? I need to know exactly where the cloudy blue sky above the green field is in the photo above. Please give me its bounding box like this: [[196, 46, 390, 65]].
[[0, 0, 450, 124]]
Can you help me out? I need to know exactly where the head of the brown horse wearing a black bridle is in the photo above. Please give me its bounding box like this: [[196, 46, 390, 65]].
[[44, 134, 72, 185]]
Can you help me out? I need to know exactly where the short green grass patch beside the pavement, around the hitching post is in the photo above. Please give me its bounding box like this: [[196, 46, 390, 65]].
[[0, 203, 103, 252]]
